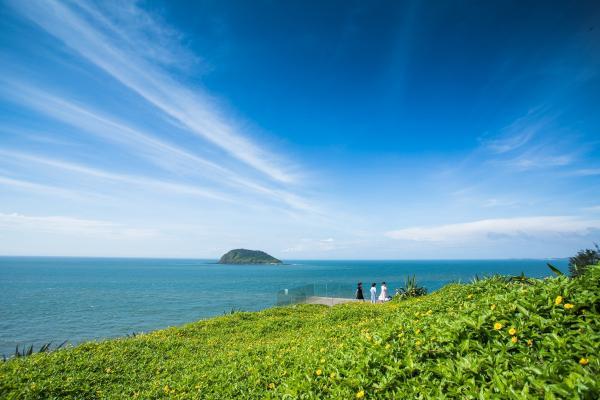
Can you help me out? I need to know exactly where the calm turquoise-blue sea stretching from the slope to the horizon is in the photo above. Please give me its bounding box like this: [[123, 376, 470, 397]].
[[0, 257, 568, 357]]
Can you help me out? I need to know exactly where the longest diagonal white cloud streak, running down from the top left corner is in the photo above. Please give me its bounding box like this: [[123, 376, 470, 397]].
[[11, 0, 294, 182]]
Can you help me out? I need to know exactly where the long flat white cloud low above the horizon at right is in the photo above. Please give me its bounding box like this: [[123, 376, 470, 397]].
[[386, 216, 600, 242]]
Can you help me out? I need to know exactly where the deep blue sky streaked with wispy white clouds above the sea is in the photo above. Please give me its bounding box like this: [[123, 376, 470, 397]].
[[0, 0, 600, 260]]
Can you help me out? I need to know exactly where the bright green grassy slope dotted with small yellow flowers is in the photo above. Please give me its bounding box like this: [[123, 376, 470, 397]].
[[0, 268, 600, 399]]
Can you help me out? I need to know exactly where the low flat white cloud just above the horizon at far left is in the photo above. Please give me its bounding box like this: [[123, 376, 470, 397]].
[[0, 213, 158, 239]]
